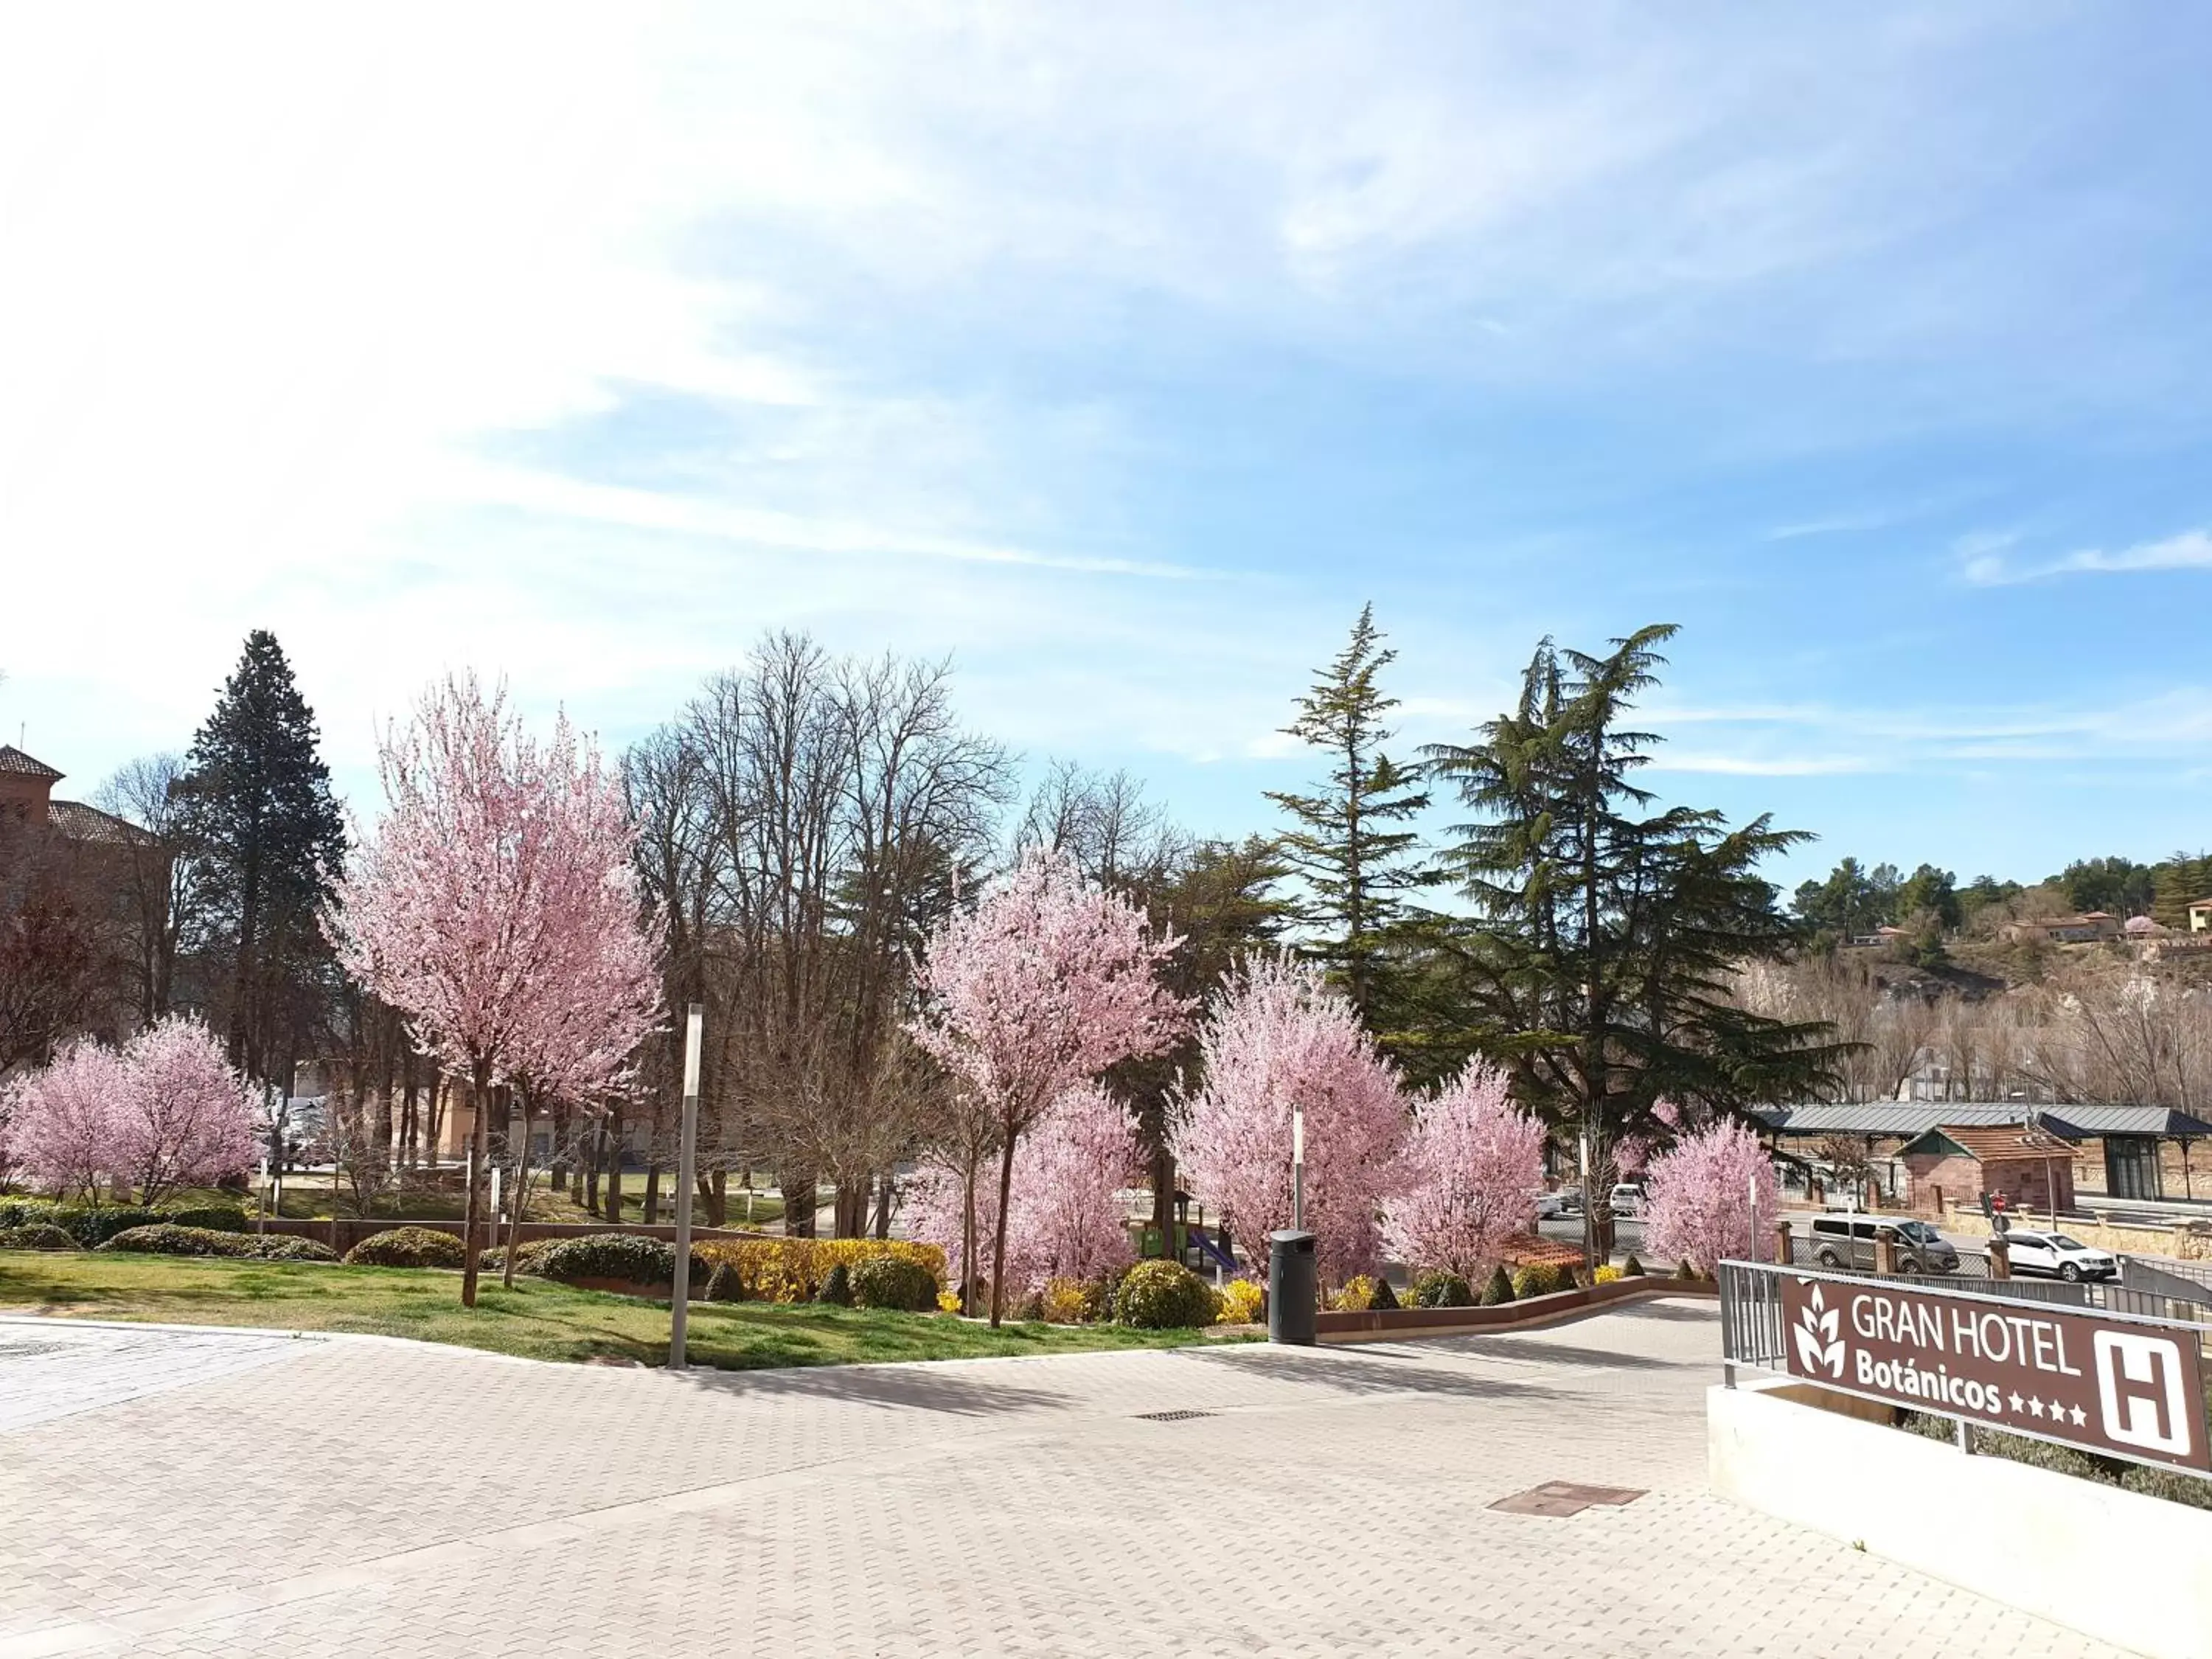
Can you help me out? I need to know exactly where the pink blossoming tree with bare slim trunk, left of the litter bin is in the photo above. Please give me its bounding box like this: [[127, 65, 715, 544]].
[[914, 852, 1188, 1325]]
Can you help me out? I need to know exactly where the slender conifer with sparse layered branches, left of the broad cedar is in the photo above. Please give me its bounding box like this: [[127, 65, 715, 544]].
[[1267, 604, 1429, 1029]]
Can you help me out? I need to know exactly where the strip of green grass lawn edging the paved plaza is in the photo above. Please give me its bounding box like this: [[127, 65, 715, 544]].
[[0, 1250, 1239, 1369]]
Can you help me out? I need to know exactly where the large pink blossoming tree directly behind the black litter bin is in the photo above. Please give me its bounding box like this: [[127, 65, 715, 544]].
[[1175, 956, 1405, 1285]]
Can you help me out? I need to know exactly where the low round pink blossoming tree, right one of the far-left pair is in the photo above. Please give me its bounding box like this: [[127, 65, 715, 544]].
[[113, 1015, 259, 1203]]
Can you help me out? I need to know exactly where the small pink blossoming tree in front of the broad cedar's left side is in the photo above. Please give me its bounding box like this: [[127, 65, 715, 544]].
[[1382, 1064, 1544, 1279]]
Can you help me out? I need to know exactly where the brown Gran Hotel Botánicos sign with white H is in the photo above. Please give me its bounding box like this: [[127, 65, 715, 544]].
[[1778, 1274, 2212, 1471]]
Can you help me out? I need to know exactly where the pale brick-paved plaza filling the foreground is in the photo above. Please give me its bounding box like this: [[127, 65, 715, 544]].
[[0, 1298, 2112, 1659]]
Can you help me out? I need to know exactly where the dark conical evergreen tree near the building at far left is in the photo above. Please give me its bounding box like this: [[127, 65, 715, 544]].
[[181, 628, 345, 1086]]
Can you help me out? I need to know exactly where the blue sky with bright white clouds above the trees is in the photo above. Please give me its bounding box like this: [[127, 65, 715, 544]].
[[0, 2, 2212, 878]]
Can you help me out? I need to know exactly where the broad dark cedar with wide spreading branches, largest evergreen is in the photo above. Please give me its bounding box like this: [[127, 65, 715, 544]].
[[1427, 626, 1840, 1250]]
